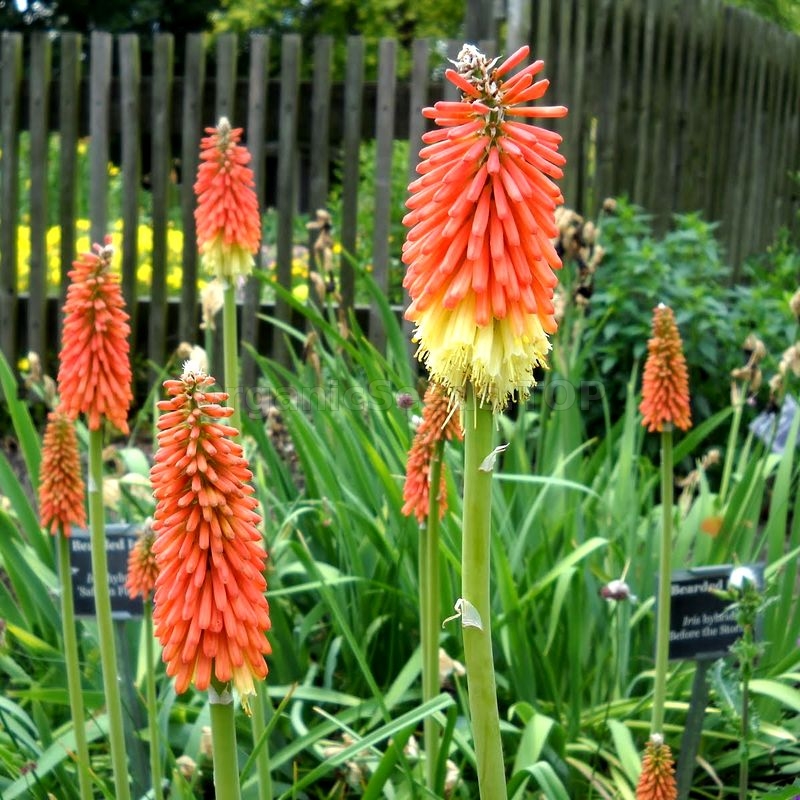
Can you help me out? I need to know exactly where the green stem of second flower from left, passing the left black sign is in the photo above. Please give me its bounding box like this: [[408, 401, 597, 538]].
[[88, 430, 130, 800]]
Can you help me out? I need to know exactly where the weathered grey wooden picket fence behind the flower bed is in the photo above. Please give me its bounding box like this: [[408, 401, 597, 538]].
[[0, 0, 800, 380]]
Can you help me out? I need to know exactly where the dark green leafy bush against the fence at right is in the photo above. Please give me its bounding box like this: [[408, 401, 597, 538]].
[[576, 199, 800, 421]]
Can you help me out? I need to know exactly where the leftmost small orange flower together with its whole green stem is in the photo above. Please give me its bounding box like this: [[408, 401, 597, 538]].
[[39, 411, 93, 800]]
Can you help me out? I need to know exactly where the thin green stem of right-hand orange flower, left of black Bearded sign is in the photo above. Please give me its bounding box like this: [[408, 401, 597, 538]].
[[652, 424, 673, 734]]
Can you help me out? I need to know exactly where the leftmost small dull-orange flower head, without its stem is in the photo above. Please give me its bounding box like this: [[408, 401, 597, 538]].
[[39, 410, 86, 536]]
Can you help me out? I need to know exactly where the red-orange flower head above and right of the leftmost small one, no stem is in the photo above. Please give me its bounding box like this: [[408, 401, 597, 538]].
[[58, 240, 133, 433]]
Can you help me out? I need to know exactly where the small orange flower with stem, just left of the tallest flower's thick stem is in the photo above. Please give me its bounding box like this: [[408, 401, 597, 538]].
[[402, 384, 464, 792]]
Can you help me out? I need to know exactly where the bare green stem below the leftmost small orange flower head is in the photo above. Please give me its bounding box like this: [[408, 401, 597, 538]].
[[58, 531, 93, 800]]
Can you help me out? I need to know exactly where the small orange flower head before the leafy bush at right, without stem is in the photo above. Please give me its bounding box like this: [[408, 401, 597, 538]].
[[639, 303, 692, 431]]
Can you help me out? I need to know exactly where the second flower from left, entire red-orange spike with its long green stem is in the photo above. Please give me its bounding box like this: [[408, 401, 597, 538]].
[[58, 242, 132, 800]]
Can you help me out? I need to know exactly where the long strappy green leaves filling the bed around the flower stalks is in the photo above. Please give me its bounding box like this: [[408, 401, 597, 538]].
[[0, 231, 800, 800]]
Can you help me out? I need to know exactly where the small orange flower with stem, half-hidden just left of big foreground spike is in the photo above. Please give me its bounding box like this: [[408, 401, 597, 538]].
[[125, 520, 164, 800]]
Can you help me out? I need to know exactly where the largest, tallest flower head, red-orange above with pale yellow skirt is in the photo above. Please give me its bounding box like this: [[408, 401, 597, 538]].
[[403, 45, 567, 410]]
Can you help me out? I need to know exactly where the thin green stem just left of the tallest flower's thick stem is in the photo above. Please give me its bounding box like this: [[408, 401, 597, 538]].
[[419, 442, 444, 794]]
